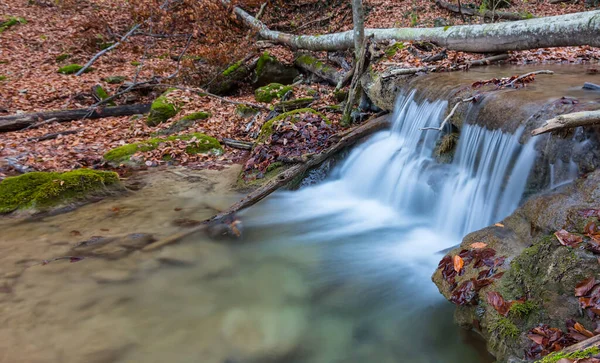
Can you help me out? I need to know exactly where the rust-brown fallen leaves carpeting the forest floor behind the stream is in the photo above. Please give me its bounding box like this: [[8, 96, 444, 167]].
[[0, 0, 600, 180]]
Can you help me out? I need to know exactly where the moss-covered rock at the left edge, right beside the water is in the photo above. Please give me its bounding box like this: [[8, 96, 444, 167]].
[[0, 169, 120, 213]]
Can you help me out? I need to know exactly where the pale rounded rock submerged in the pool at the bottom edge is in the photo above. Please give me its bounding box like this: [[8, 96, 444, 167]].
[[221, 306, 308, 362]]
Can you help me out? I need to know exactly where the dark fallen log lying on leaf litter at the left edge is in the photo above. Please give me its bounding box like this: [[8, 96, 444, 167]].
[[0, 103, 150, 132]]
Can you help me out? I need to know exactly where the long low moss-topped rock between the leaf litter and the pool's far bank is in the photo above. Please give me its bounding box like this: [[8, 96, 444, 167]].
[[104, 132, 223, 165]]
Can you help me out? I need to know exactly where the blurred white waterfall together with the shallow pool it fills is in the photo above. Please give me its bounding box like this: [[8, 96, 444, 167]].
[[0, 94, 535, 363]]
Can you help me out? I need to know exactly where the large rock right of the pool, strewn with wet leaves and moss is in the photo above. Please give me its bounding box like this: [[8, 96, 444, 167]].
[[433, 171, 600, 361]]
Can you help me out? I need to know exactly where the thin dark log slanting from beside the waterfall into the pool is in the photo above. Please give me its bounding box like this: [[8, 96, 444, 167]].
[[143, 116, 390, 251]]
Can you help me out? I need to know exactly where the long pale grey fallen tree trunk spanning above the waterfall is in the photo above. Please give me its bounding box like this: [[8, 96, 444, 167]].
[[222, 0, 600, 53]]
